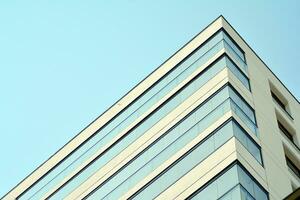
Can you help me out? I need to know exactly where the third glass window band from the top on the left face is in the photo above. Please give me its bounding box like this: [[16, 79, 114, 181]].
[[64, 89, 232, 198]]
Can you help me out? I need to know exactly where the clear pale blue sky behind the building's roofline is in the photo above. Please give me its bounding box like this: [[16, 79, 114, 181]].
[[0, 0, 300, 196]]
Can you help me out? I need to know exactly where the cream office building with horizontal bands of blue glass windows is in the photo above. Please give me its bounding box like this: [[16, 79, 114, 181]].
[[4, 16, 300, 200]]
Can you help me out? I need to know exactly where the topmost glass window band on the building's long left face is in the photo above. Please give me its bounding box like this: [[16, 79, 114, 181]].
[[20, 27, 234, 199]]
